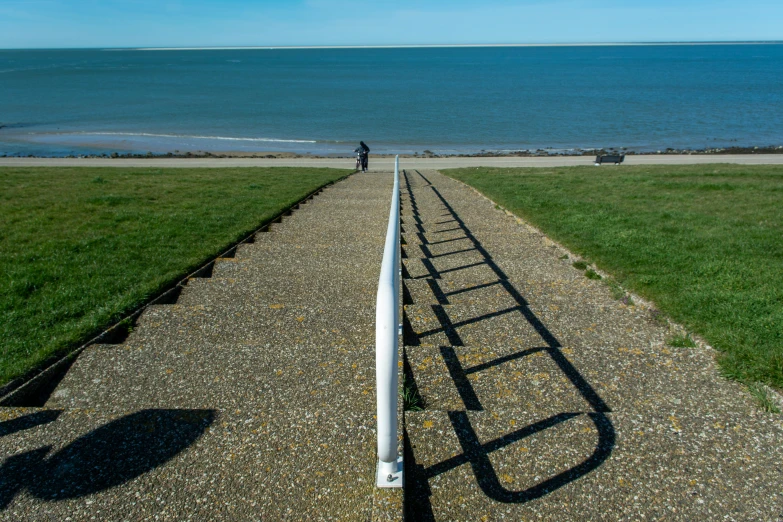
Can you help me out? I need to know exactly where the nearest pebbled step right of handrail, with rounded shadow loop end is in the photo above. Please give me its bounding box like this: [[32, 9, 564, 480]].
[[406, 404, 783, 520]]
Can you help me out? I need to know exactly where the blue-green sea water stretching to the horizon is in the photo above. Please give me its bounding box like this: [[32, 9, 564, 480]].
[[0, 44, 783, 156]]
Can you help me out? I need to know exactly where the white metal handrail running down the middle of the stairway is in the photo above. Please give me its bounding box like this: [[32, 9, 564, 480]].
[[375, 156, 402, 488]]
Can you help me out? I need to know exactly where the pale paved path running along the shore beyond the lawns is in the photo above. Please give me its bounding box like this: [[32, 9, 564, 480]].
[[0, 154, 783, 172]]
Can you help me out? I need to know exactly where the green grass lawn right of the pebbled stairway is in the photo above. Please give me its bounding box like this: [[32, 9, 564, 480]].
[[444, 165, 783, 389]]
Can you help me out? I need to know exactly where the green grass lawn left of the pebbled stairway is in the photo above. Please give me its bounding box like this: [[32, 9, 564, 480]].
[[0, 168, 350, 385]]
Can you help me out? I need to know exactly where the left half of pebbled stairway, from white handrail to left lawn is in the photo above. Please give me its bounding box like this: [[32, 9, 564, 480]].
[[0, 172, 392, 521]]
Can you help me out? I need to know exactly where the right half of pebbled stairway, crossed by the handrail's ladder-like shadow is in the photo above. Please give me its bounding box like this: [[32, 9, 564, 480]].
[[403, 169, 783, 521]]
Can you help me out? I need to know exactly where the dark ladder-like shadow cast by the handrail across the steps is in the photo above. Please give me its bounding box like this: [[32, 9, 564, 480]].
[[403, 171, 615, 520]]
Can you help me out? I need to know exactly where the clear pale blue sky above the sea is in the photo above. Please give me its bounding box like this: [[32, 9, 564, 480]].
[[0, 0, 783, 49]]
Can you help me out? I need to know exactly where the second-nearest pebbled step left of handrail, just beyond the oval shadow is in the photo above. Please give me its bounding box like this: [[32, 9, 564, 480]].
[[46, 335, 375, 417]]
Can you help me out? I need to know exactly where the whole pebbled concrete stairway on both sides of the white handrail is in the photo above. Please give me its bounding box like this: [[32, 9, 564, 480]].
[[0, 164, 783, 521]]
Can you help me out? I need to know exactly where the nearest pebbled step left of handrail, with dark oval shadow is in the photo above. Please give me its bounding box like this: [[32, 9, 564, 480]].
[[0, 404, 375, 520]]
